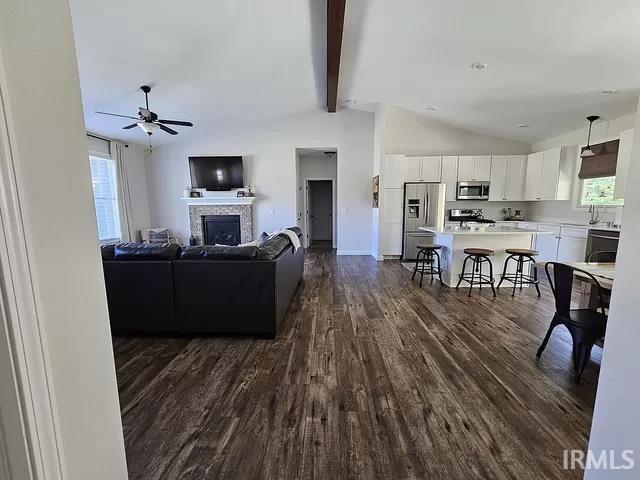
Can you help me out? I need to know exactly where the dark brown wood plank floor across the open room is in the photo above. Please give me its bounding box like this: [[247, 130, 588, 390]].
[[114, 251, 601, 480]]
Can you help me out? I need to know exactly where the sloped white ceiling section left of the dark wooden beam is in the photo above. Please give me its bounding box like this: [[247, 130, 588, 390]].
[[71, 0, 326, 144]]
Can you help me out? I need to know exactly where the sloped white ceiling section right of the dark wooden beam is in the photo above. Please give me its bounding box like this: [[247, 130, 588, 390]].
[[339, 0, 640, 142]]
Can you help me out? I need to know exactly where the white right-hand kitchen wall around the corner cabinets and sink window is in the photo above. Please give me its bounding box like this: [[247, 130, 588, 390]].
[[530, 115, 635, 223]]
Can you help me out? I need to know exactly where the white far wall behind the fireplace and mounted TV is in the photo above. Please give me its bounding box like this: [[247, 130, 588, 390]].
[[147, 109, 373, 254]]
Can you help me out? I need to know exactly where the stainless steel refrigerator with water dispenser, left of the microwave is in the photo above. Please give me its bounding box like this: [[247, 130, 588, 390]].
[[402, 182, 446, 260]]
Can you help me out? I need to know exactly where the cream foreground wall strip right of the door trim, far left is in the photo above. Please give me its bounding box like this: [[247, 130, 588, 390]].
[[0, 0, 127, 480]]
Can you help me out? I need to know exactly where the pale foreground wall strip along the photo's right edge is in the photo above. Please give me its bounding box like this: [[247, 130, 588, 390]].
[[585, 101, 640, 480]]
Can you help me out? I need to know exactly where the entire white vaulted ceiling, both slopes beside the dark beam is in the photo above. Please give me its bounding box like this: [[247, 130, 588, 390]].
[[71, 0, 640, 144]]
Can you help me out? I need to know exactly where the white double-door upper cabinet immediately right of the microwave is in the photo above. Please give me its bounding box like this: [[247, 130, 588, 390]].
[[489, 155, 527, 202]]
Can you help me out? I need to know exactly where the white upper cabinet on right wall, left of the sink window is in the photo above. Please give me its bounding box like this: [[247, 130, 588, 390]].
[[524, 147, 575, 200]]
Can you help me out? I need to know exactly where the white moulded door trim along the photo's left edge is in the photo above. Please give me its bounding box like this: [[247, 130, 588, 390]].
[[0, 46, 66, 480]]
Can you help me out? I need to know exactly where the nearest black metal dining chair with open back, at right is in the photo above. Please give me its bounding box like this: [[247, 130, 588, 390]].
[[536, 262, 607, 383]]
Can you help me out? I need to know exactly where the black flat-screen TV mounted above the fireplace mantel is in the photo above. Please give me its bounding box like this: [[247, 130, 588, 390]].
[[189, 157, 244, 191]]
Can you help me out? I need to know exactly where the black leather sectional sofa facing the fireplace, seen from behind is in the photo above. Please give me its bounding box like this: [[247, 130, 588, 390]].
[[102, 227, 304, 338]]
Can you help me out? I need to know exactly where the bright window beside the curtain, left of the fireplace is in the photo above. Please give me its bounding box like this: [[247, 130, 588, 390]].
[[89, 155, 120, 242]]
